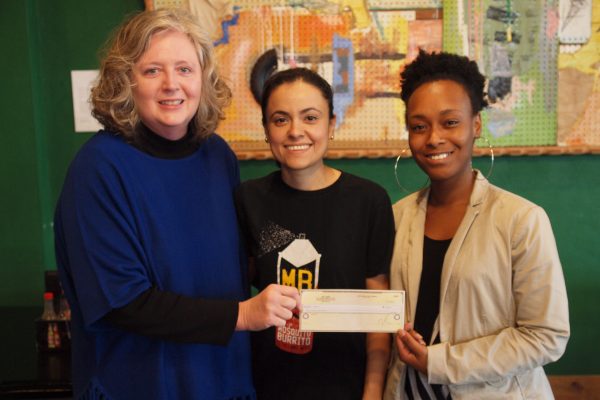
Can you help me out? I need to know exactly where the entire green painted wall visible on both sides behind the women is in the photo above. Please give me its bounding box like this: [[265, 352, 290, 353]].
[[0, 0, 600, 374]]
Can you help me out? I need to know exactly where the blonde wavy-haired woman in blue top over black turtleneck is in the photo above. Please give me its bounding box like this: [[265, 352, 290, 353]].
[[55, 10, 299, 399]]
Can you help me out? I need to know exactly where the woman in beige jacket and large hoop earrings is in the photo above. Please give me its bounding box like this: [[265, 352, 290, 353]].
[[385, 52, 569, 399]]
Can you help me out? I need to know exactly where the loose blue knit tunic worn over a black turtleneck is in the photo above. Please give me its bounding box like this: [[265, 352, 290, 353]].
[[55, 131, 254, 399]]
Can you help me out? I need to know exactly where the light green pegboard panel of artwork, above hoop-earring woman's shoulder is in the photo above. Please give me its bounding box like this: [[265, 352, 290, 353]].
[[444, 0, 558, 146]]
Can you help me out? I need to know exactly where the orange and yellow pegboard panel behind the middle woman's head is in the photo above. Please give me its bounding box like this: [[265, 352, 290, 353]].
[[206, 0, 442, 158]]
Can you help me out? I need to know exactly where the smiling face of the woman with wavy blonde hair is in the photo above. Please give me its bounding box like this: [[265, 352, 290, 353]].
[[132, 30, 202, 140]]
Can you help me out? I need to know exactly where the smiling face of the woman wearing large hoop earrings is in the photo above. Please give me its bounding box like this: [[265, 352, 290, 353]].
[[406, 80, 481, 186]]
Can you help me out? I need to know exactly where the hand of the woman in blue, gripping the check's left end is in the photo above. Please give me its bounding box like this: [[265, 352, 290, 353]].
[[235, 284, 300, 331]]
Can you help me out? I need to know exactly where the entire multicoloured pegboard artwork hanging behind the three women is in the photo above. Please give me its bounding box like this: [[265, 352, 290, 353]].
[[145, 0, 600, 158]]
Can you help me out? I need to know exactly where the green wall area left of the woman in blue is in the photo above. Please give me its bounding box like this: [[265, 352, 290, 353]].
[[0, 0, 144, 306]]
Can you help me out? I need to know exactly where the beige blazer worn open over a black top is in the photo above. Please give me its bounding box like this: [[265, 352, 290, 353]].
[[384, 172, 570, 400]]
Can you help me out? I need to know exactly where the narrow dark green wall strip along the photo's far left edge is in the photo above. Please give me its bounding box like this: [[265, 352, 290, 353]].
[[0, 0, 42, 310]]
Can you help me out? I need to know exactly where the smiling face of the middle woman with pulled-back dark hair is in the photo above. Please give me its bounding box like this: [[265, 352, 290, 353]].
[[265, 80, 335, 175]]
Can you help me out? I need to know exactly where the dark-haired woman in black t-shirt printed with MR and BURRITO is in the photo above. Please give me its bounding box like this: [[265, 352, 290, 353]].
[[236, 68, 394, 400]]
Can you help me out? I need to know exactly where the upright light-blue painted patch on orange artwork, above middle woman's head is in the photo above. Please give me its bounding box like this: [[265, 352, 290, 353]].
[[332, 34, 354, 126]]
